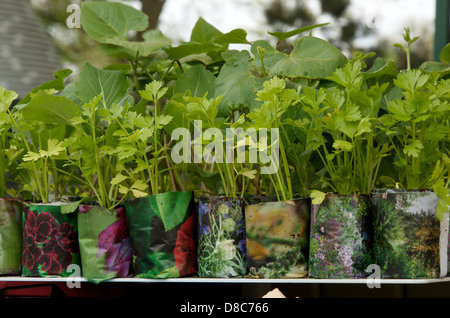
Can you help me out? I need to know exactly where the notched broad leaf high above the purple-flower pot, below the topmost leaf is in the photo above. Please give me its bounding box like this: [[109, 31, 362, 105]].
[[76, 63, 127, 108]]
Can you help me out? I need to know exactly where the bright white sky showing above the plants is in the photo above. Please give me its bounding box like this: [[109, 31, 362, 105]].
[[159, 0, 435, 50]]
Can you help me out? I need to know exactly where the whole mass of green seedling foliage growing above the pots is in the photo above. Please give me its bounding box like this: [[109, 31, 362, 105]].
[[0, 1, 450, 225]]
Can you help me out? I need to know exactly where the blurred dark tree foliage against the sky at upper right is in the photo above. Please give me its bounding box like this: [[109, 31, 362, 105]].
[[265, 0, 433, 69]]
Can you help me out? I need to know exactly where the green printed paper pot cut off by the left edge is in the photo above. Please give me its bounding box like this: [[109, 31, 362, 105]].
[[0, 198, 23, 275]]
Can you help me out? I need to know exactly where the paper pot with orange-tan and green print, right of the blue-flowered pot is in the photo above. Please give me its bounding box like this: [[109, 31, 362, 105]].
[[245, 199, 311, 278]]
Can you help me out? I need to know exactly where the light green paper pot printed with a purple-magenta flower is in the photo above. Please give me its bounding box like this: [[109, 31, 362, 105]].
[[78, 205, 132, 283]]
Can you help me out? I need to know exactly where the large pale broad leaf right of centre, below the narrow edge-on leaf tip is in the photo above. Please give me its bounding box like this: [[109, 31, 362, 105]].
[[270, 36, 347, 79]]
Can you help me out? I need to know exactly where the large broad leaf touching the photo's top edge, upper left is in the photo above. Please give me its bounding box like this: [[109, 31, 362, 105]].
[[81, 1, 149, 44]]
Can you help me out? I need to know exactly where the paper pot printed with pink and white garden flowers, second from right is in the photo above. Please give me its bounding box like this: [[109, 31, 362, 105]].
[[309, 194, 373, 278]]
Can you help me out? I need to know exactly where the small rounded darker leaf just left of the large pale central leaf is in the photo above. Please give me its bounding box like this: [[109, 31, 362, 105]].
[[173, 66, 216, 97]]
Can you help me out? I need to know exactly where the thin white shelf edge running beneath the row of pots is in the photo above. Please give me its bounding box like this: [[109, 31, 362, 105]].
[[0, 276, 450, 285]]
